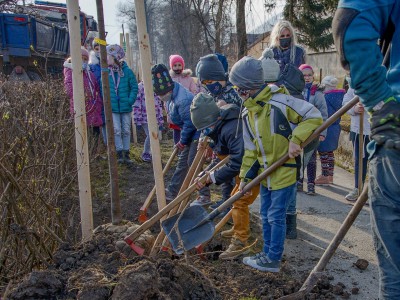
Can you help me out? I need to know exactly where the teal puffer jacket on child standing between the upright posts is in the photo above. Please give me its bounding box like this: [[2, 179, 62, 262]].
[[109, 62, 138, 113]]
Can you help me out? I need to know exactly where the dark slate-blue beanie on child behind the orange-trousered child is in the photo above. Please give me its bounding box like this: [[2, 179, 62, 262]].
[[196, 54, 226, 81]]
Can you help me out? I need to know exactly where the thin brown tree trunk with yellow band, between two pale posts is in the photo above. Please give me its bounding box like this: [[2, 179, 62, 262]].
[[96, 0, 122, 225]]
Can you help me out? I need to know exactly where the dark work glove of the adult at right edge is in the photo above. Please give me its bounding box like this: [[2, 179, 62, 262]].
[[370, 97, 400, 150]]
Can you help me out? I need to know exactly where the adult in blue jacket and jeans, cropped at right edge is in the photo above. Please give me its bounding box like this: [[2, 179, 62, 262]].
[[333, 0, 400, 299]]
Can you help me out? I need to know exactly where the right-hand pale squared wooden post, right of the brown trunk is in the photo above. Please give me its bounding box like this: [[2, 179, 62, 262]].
[[135, 0, 166, 211]]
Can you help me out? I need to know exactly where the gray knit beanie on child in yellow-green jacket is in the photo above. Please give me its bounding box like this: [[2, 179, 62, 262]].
[[229, 56, 264, 90]]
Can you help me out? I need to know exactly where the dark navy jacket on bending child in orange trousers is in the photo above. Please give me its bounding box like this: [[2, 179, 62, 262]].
[[208, 104, 244, 184]]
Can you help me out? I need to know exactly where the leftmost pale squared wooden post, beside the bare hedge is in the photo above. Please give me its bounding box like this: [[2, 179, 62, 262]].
[[67, 0, 93, 241]]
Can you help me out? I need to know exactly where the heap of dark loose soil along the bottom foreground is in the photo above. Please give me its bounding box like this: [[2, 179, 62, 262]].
[[6, 223, 351, 300]]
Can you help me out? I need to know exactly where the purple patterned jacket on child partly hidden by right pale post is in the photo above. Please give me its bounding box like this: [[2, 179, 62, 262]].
[[133, 82, 164, 126]]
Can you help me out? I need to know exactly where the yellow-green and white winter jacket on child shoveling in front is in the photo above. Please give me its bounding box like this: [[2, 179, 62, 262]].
[[239, 86, 322, 190]]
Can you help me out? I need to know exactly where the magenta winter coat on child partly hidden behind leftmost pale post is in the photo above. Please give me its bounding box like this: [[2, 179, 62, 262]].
[[64, 62, 103, 127]]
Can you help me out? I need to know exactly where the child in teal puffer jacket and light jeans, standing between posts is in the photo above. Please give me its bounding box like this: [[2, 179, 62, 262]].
[[107, 45, 138, 164]]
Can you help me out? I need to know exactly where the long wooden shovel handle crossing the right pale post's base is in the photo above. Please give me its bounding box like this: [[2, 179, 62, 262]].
[[125, 156, 229, 241]]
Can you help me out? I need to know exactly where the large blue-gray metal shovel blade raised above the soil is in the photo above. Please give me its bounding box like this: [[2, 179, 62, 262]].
[[161, 205, 215, 254]]
